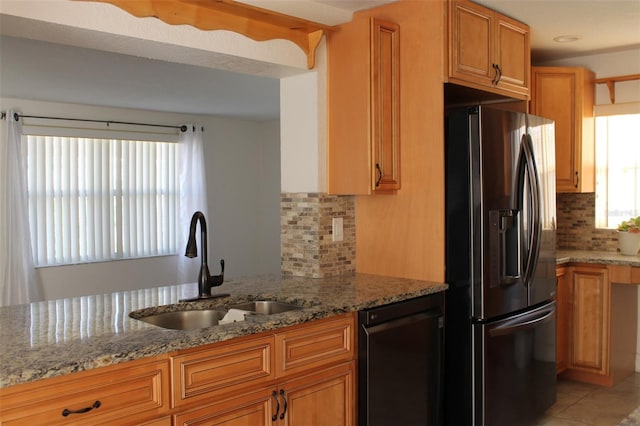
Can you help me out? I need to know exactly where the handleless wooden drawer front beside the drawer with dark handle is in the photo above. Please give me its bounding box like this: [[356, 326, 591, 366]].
[[172, 336, 274, 407]]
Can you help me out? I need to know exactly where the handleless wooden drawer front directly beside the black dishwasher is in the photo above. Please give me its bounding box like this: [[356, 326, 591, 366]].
[[276, 314, 355, 377]]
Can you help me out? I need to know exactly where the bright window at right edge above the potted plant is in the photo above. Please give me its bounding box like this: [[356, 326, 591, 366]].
[[596, 104, 640, 228]]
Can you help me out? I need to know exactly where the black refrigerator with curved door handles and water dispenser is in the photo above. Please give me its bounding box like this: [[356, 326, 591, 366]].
[[444, 106, 556, 426]]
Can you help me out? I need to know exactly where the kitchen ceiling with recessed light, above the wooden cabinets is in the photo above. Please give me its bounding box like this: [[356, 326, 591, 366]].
[[239, 0, 640, 63]]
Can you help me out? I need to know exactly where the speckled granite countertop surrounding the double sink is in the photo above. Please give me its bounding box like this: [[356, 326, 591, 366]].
[[0, 274, 447, 388]]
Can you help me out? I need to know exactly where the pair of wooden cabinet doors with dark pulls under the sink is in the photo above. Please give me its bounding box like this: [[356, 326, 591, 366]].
[[174, 361, 355, 426]]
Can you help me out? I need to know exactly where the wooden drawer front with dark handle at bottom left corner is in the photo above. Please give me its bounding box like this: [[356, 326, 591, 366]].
[[0, 360, 169, 425]]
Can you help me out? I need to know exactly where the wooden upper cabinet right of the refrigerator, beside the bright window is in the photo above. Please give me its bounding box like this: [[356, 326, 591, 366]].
[[531, 67, 595, 192]]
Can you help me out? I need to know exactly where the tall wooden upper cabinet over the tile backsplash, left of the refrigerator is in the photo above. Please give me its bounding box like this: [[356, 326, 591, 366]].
[[327, 17, 400, 194]]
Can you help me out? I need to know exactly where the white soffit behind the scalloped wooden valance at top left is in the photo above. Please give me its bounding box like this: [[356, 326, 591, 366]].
[[0, 0, 307, 73]]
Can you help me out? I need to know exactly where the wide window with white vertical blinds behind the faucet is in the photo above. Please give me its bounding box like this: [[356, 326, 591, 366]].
[[22, 135, 179, 266]]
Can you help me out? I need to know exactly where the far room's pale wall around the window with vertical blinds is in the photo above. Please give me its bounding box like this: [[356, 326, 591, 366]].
[[0, 98, 280, 299]]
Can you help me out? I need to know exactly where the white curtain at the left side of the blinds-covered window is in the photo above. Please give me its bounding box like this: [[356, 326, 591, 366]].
[[0, 110, 40, 306]]
